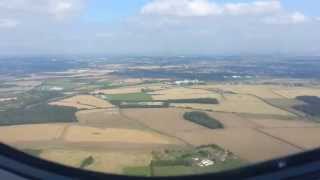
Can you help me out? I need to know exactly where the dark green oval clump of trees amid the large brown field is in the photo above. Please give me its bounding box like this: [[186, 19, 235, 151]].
[[183, 111, 224, 129]]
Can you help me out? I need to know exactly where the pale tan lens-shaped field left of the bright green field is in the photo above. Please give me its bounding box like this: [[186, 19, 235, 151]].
[[49, 95, 114, 109]]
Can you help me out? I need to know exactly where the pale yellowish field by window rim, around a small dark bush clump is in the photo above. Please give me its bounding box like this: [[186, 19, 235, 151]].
[[40, 149, 152, 174]]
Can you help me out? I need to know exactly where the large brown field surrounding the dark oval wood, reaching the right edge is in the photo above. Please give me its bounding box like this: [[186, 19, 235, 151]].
[[123, 108, 320, 162]]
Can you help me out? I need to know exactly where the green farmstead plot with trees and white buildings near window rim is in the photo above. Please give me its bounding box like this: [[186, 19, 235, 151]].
[[150, 145, 246, 176]]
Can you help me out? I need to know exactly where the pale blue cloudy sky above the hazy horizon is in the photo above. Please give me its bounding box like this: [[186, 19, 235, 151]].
[[0, 0, 320, 55]]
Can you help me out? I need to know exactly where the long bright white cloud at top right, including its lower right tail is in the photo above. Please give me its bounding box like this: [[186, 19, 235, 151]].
[[141, 0, 315, 25]]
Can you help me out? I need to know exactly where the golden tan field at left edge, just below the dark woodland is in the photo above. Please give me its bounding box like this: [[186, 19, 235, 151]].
[[0, 124, 66, 144]]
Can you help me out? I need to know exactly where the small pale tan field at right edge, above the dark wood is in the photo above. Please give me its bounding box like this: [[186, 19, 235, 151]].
[[275, 87, 320, 99]]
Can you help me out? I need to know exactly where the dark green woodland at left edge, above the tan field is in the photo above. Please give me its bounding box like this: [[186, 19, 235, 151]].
[[0, 90, 77, 126]]
